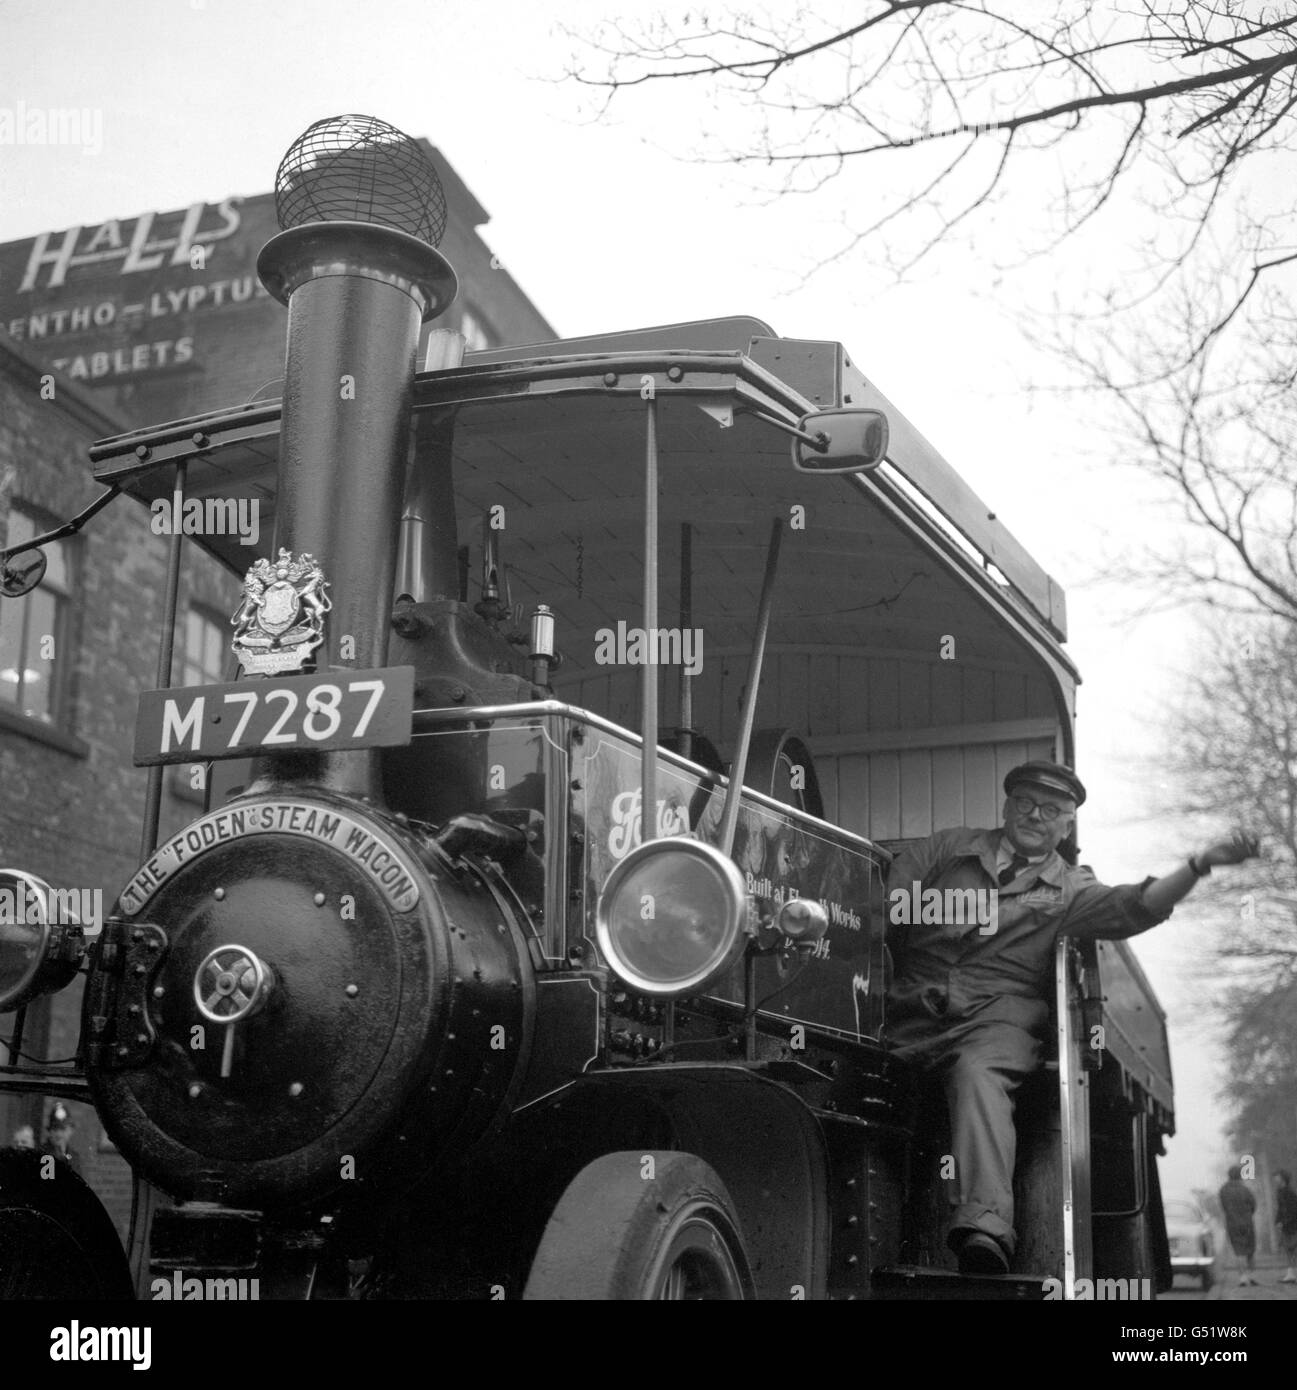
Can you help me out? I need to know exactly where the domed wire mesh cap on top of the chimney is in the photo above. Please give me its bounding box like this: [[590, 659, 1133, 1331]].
[[275, 115, 446, 246]]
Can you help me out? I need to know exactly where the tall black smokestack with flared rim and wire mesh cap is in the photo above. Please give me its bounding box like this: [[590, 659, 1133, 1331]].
[[257, 115, 457, 795]]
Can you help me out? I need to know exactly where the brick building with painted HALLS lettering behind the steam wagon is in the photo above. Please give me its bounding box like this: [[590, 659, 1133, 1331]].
[[0, 146, 555, 1234]]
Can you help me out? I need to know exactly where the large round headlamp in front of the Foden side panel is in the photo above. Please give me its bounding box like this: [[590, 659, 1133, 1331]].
[[595, 838, 748, 999]]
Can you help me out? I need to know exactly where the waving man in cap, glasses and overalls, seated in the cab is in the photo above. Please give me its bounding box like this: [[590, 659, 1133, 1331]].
[[887, 762, 1257, 1275]]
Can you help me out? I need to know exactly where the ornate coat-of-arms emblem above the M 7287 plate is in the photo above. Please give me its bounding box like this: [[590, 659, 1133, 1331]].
[[229, 550, 334, 676]]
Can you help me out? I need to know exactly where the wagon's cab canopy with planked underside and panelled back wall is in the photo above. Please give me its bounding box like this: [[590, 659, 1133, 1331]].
[[92, 318, 1076, 840]]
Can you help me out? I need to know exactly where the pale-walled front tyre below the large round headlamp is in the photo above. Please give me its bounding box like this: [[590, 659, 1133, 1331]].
[[523, 1151, 755, 1302]]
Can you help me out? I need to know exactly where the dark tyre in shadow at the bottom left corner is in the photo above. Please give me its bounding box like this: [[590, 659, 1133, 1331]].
[[0, 1148, 135, 1301]]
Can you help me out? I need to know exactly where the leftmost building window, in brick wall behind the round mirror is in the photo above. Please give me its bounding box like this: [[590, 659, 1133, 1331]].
[[0, 502, 72, 724]]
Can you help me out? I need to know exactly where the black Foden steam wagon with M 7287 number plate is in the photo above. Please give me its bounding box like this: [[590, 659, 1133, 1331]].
[[0, 117, 1173, 1300]]
